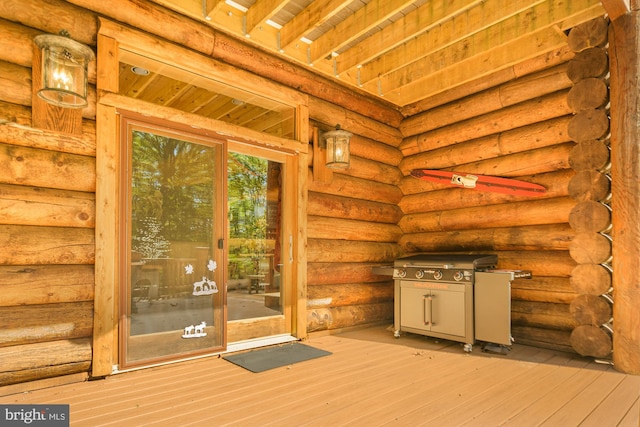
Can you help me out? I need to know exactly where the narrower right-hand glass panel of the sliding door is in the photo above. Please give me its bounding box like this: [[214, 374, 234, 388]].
[[227, 146, 290, 342]]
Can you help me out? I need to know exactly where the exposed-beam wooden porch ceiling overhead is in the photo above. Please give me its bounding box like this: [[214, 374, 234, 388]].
[[149, 0, 605, 107]]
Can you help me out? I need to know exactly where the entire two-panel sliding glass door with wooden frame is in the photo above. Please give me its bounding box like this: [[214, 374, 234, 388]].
[[118, 113, 295, 369]]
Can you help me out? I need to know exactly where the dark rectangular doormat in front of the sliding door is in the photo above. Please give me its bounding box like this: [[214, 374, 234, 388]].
[[223, 342, 331, 372]]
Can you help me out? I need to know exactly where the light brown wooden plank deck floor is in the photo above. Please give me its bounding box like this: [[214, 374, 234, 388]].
[[0, 327, 640, 427]]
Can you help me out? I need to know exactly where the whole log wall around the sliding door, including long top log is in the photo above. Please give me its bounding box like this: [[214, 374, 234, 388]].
[[0, 0, 402, 386]]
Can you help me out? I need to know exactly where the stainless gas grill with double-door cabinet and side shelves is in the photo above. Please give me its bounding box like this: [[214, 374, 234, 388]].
[[373, 254, 530, 351]]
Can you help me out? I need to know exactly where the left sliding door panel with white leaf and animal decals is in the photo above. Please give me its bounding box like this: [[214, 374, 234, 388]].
[[120, 117, 226, 367]]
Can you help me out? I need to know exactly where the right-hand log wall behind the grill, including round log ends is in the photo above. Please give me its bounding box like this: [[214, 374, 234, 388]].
[[399, 19, 611, 357]]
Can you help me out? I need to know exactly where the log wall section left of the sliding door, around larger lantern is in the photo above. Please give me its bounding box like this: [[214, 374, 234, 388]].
[[0, 23, 96, 386]]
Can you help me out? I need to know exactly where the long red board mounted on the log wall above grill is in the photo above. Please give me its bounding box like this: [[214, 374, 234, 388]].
[[411, 169, 547, 197]]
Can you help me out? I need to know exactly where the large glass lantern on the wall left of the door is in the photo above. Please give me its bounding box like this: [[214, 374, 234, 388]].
[[34, 30, 95, 108]]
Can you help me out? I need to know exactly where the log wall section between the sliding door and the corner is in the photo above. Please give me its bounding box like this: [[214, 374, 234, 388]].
[[307, 113, 402, 332]]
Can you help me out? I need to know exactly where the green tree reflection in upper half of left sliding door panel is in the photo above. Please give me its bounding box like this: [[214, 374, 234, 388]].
[[131, 131, 215, 254]]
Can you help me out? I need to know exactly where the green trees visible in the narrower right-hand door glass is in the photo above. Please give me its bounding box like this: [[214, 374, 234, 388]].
[[227, 153, 268, 242]]
